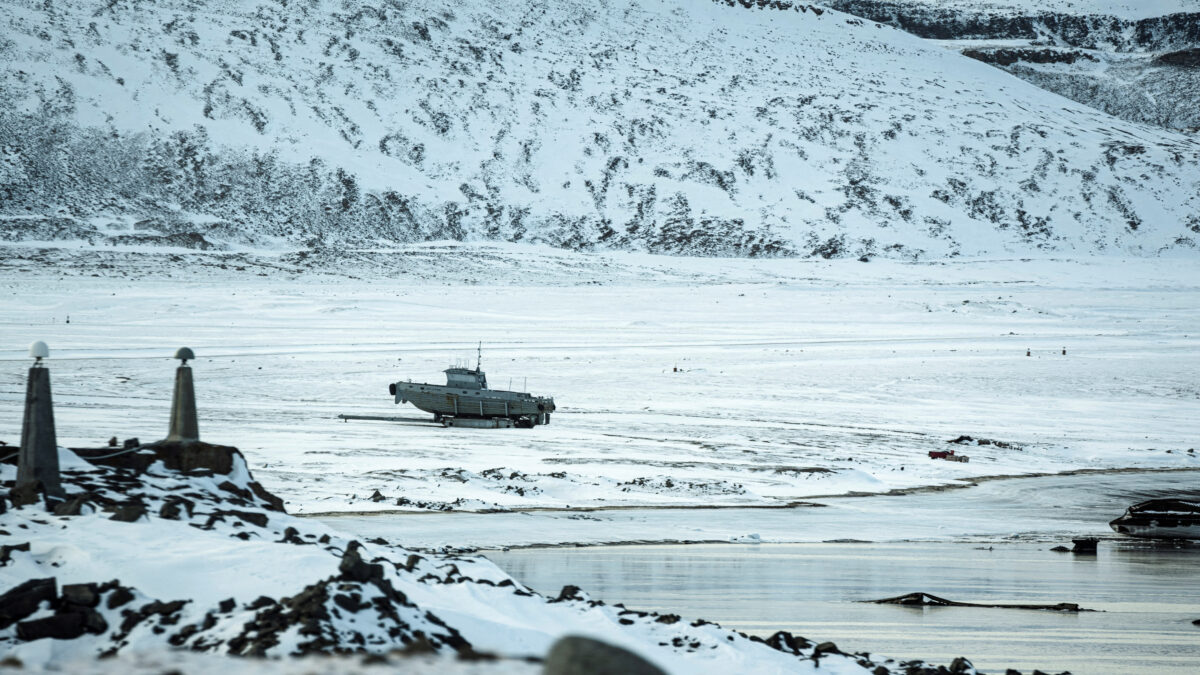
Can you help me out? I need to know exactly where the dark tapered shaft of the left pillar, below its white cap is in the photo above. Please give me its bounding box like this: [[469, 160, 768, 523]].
[[16, 359, 65, 497]]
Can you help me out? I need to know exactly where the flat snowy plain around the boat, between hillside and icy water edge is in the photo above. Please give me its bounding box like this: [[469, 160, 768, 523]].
[[0, 245, 1200, 513]]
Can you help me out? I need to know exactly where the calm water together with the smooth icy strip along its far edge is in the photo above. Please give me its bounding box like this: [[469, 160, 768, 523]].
[[324, 471, 1200, 675]]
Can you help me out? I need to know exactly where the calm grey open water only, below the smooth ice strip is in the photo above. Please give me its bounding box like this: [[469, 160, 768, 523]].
[[487, 540, 1200, 675]]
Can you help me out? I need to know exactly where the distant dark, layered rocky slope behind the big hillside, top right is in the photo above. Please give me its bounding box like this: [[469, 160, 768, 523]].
[[829, 0, 1200, 131]]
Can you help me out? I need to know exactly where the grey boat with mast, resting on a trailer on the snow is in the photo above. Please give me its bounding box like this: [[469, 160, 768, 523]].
[[388, 347, 554, 428]]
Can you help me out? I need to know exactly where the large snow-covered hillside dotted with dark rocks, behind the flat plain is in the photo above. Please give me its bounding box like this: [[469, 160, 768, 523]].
[[0, 0, 1200, 257]]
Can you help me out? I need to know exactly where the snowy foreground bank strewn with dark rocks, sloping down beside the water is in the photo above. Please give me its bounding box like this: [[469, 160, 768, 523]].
[[0, 442, 964, 673]]
